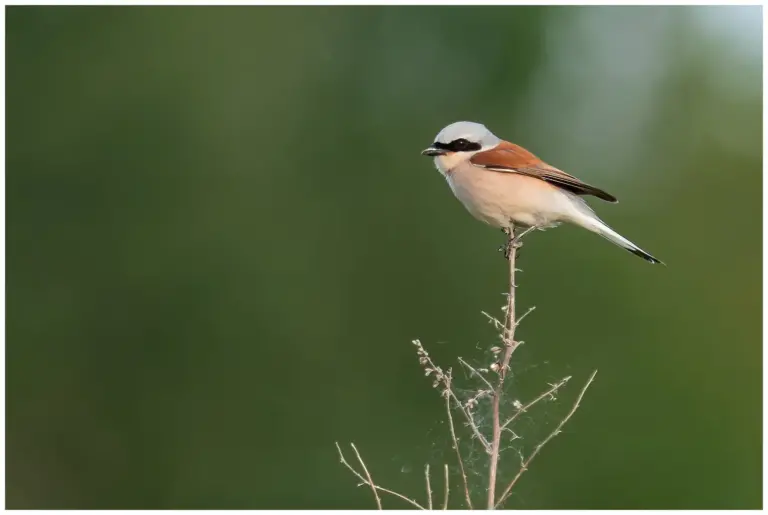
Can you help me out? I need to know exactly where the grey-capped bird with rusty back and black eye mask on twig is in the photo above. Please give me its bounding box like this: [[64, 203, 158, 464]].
[[422, 121, 663, 264]]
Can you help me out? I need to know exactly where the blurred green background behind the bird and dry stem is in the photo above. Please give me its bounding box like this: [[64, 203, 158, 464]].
[[6, 7, 762, 508]]
